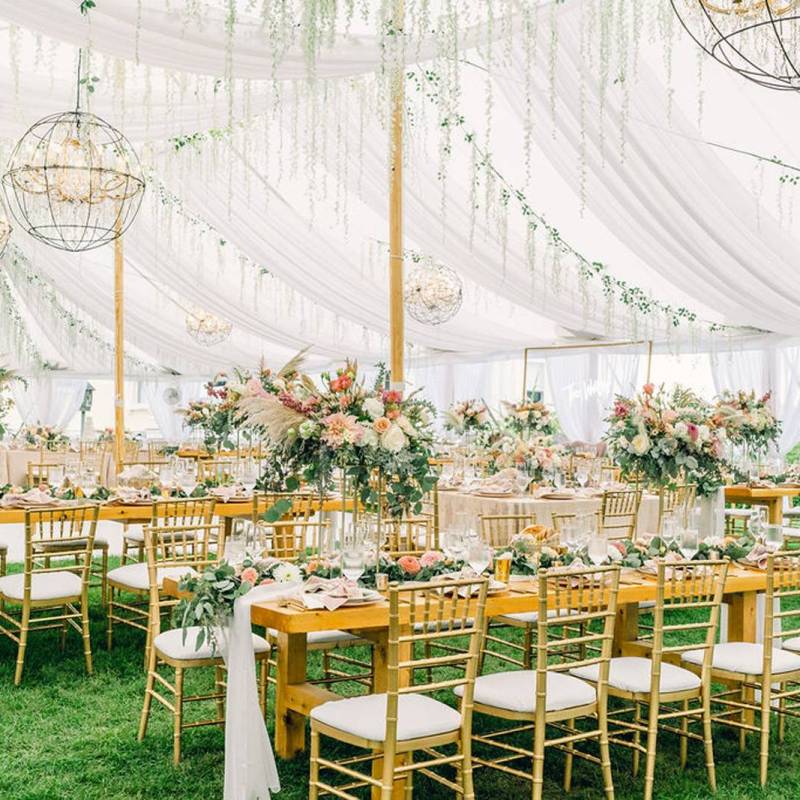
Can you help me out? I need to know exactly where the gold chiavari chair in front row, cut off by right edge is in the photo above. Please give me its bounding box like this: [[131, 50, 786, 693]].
[[683, 551, 800, 788]]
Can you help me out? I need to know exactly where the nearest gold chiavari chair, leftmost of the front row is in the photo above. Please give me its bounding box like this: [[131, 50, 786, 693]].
[[308, 579, 486, 800]]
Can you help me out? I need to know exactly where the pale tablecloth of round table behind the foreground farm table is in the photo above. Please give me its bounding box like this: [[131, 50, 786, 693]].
[[439, 489, 658, 534]]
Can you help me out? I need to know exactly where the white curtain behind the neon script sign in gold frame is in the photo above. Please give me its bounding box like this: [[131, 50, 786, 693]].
[[546, 349, 639, 443]]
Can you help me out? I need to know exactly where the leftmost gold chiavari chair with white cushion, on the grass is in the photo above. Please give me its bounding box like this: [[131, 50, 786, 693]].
[[0, 505, 99, 686]]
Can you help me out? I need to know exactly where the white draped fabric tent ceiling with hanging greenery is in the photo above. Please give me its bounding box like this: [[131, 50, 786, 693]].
[[0, 0, 800, 390]]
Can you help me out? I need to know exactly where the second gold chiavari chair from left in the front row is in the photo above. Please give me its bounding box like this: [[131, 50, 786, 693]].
[[472, 567, 619, 800]]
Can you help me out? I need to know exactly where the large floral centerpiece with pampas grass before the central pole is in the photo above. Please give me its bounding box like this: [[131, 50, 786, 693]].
[[237, 361, 436, 516]]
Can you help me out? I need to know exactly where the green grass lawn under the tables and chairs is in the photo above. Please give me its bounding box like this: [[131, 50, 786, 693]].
[[0, 564, 800, 800]]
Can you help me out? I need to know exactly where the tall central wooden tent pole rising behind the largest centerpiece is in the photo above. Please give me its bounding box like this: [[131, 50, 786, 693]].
[[389, 0, 405, 389]]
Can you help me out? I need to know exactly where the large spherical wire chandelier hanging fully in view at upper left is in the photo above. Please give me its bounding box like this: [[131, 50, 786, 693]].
[[2, 53, 145, 252]]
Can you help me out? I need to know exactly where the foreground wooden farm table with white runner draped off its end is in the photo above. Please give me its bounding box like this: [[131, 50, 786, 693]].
[[170, 566, 766, 758]]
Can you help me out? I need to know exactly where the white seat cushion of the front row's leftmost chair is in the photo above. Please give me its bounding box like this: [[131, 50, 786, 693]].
[[311, 694, 461, 742]]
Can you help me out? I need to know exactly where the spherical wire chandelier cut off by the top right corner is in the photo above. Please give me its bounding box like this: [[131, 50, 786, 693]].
[[670, 0, 800, 91]]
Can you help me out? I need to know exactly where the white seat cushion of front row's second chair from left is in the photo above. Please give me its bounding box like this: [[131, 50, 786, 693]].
[[454, 669, 597, 714]]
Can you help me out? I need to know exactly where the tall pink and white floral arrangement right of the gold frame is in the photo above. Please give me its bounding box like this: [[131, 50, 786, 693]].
[[604, 384, 727, 497]]
